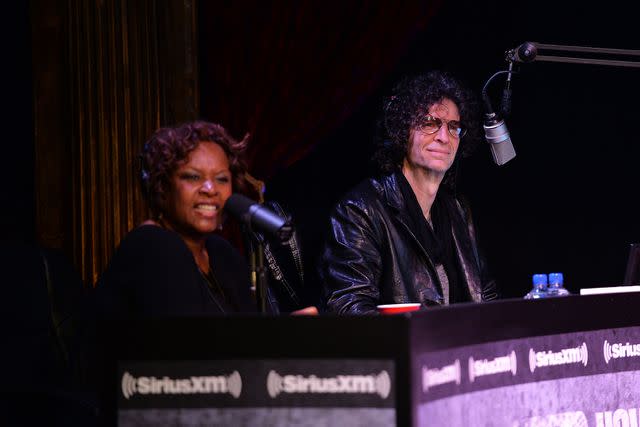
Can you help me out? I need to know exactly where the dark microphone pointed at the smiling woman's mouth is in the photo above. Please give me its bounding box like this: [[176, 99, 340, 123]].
[[224, 193, 293, 243]]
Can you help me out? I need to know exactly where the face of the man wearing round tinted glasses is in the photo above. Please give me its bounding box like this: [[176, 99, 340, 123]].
[[405, 98, 460, 174]]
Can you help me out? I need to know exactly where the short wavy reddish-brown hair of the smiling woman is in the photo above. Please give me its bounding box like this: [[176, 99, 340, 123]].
[[140, 121, 252, 214]]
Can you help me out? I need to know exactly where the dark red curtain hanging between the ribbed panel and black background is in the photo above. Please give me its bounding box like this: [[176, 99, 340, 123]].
[[198, 0, 441, 180]]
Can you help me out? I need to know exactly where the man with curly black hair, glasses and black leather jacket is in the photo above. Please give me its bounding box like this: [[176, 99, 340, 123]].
[[320, 71, 497, 314]]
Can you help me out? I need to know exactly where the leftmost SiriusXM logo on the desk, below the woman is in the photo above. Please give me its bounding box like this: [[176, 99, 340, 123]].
[[121, 371, 242, 399]]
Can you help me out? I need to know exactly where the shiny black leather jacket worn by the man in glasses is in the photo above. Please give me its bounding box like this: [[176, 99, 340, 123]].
[[320, 174, 498, 314]]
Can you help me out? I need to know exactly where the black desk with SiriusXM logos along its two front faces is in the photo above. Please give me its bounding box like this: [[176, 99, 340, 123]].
[[102, 294, 640, 427]]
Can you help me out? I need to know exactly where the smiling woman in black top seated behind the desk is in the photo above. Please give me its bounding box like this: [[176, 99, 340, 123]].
[[96, 121, 255, 317]]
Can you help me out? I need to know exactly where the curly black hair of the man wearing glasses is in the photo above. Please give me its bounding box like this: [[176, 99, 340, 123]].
[[373, 71, 480, 181]]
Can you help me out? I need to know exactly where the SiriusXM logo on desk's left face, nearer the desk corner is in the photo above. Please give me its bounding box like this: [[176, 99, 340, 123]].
[[267, 370, 391, 399]]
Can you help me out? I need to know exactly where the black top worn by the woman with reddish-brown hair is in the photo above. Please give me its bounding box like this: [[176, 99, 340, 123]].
[[94, 225, 256, 318]]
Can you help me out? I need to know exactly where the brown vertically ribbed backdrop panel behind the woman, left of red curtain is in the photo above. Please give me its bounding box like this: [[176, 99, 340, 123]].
[[31, 0, 199, 285]]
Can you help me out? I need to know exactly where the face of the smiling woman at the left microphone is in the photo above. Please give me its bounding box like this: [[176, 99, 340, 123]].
[[163, 141, 232, 238]]
